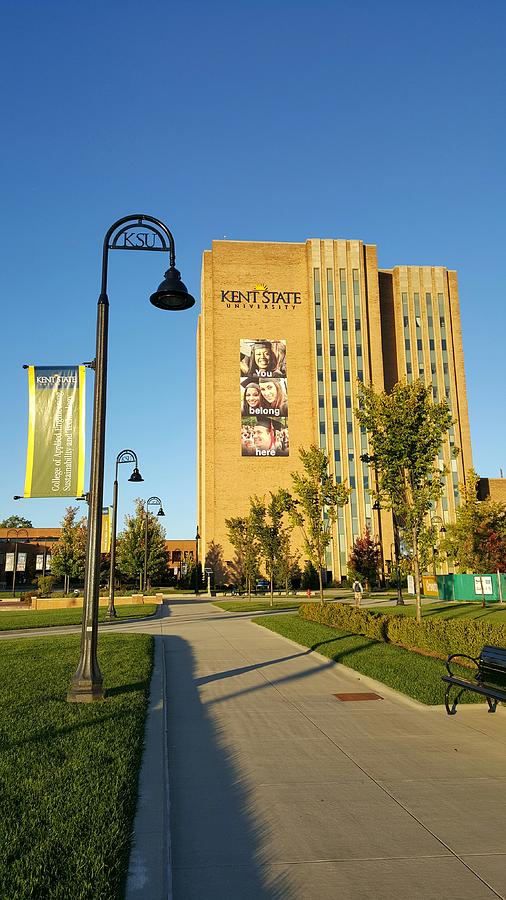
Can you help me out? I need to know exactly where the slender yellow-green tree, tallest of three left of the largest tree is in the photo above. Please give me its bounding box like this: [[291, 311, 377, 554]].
[[288, 444, 349, 604]]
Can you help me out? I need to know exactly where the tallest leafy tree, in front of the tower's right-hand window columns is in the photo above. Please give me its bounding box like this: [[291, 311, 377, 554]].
[[356, 380, 458, 622]]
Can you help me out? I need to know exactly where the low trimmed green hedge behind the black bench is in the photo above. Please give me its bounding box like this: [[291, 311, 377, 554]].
[[299, 603, 506, 657]]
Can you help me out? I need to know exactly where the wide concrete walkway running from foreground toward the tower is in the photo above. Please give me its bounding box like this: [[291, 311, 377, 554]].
[[126, 601, 506, 900]]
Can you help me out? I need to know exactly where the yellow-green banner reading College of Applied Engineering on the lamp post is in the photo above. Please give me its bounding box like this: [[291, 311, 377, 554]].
[[24, 366, 86, 497]]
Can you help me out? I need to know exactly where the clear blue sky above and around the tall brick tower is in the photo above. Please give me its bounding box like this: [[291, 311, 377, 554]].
[[0, 0, 506, 537]]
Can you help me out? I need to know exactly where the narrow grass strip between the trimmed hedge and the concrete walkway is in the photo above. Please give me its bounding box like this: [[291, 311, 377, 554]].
[[253, 615, 480, 705]]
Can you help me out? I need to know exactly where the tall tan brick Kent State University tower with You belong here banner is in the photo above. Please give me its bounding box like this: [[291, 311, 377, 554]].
[[197, 239, 472, 580]]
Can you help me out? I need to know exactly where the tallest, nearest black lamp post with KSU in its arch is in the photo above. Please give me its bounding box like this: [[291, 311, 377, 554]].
[[67, 213, 195, 703]]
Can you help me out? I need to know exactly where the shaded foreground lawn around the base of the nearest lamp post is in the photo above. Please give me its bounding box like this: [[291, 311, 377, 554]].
[[0, 635, 153, 900]]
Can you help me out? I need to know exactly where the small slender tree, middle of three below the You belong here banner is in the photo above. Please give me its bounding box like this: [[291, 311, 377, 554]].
[[250, 488, 290, 606]]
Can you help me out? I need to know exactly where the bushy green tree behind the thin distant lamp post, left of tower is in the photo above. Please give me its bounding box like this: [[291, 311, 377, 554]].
[[116, 499, 168, 584]]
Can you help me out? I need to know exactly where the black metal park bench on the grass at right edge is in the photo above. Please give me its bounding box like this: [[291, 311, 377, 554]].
[[442, 647, 506, 716]]
